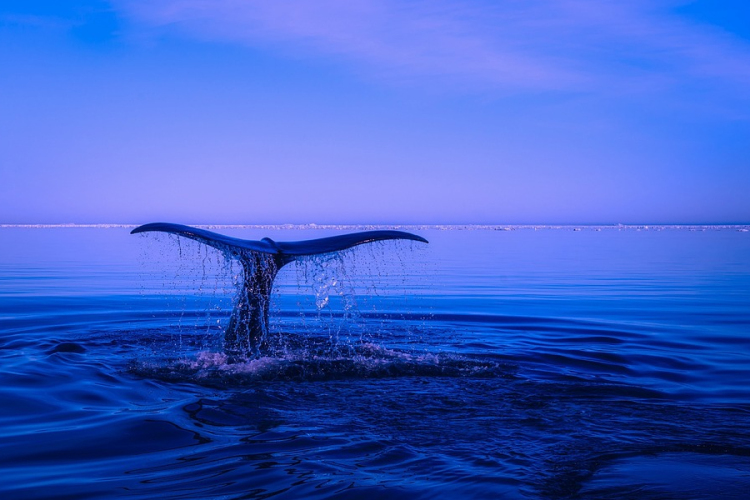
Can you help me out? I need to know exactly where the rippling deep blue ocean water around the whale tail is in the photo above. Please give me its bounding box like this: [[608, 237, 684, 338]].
[[0, 226, 750, 500]]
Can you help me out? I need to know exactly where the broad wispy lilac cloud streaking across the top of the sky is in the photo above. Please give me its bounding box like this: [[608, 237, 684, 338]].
[[116, 0, 750, 94]]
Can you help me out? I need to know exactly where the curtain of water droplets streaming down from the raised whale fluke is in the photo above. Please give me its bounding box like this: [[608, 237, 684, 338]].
[[135, 235, 428, 362]]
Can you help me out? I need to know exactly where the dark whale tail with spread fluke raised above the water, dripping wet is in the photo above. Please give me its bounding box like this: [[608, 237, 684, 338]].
[[131, 222, 428, 358]]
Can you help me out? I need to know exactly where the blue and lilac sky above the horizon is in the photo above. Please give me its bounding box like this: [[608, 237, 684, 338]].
[[0, 0, 750, 224]]
